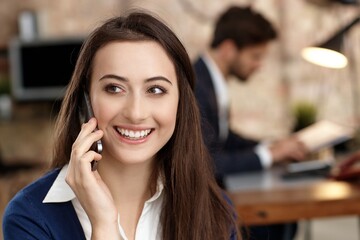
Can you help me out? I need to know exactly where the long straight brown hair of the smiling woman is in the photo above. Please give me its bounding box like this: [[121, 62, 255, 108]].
[[53, 9, 240, 240]]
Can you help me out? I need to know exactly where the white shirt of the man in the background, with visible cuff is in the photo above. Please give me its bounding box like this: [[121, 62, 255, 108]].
[[202, 53, 272, 168]]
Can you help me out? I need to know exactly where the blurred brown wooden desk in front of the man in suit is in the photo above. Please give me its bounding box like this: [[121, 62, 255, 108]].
[[225, 169, 360, 225]]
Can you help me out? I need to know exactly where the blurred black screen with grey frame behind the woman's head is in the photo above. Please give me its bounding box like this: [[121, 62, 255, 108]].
[[9, 38, 83, 101]]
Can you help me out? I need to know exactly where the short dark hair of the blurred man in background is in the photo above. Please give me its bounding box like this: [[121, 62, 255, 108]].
[[211, 6, 277, 49]]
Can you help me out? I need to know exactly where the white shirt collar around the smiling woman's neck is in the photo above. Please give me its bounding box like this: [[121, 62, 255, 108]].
[[43, 165, 164, 203]]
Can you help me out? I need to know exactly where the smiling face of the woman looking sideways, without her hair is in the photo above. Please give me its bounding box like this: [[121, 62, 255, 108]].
[[90, 41, 179, 164]]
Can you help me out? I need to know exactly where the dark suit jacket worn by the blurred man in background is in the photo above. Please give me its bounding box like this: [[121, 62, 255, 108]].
[[194, 58, 262, 180]]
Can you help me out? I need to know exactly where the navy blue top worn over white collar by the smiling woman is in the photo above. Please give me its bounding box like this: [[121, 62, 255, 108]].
[[3, 169, 236, 240]]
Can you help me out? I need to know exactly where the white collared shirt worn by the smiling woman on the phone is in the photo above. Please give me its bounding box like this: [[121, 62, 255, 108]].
[[43, 165, 164, 240]]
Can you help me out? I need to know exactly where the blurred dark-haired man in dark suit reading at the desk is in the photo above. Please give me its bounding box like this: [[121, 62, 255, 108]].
[[194, 7, 307, 240]]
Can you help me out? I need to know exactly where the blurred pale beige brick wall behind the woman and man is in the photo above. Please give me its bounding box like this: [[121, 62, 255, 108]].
[[0, 0, 360, 142]]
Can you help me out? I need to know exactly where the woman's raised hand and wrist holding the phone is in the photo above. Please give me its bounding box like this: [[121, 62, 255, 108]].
[[65, 118, 119, 239]]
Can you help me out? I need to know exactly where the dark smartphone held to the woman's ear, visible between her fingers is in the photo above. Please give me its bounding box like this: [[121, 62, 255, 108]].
[[80, 91, 103, 171]]
